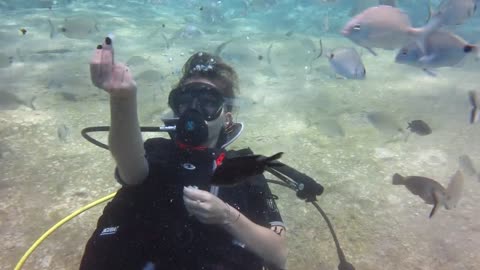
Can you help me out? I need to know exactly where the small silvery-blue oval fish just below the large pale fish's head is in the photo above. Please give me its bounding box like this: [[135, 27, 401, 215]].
[[327, 48, 367, 80]]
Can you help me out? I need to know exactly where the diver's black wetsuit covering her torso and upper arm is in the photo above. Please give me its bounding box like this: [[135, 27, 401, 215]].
[[80, 138, 283, 270]]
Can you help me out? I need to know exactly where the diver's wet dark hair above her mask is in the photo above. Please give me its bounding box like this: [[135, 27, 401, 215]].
[[174, 52, 239, 112]]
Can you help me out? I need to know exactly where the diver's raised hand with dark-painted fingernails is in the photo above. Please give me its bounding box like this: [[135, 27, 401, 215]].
[[90, 37, 137, 96]]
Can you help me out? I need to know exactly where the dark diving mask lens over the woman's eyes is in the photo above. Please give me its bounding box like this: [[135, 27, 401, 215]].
[[171, 83, 224, 121]]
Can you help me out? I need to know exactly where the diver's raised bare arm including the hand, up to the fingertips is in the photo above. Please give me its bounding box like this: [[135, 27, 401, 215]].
[[90, 37, 148, 185]]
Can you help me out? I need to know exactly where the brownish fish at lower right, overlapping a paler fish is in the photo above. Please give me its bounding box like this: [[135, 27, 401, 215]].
[[392, 173, 447, 218]]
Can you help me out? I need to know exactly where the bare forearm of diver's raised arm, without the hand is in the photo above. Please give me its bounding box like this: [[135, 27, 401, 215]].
[[108, 92, 148, 185]]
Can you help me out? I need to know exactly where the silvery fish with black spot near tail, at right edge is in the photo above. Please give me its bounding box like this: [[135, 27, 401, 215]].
[[395, 30, 479, 73]]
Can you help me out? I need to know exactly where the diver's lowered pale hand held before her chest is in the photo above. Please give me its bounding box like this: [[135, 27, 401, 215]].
[[183, 187, 237, 224]]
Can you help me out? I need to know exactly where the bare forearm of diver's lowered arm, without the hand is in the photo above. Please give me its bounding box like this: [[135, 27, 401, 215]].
[[224, 206, 287, 269]]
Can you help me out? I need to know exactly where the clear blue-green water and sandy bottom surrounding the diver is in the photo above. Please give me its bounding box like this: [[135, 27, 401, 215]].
[[0, 0, 480, 270]]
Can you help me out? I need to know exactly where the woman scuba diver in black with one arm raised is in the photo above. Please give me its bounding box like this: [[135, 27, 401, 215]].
[[80, 38, 287, 270]]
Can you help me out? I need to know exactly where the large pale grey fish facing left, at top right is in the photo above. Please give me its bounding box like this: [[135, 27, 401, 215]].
[[342, 5, 429, 55]]
